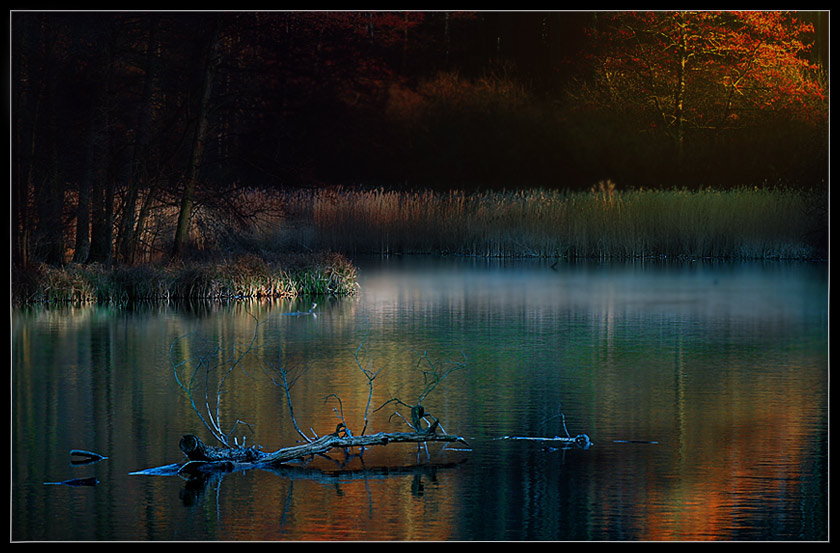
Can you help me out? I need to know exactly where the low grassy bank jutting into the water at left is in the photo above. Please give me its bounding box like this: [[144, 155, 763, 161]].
[[13, 253, 358, 304]]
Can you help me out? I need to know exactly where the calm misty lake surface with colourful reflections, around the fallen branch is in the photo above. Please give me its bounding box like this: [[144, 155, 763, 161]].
[[11, 257, 828, 541]]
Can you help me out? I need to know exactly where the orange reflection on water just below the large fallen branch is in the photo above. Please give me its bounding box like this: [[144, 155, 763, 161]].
[[210, 454, 458, 541]]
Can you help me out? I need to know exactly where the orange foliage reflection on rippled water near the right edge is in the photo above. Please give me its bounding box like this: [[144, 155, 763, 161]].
[[639, 362, 815, 541]]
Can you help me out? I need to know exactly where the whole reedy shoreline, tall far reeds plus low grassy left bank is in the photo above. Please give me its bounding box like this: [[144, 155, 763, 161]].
[[11, 185, 828, 306]]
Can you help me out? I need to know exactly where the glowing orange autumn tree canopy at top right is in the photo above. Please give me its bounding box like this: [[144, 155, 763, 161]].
[[576, 11, 827, 155]]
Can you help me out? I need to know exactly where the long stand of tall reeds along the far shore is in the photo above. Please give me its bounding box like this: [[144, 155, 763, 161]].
[[286, 181, 816, 259]]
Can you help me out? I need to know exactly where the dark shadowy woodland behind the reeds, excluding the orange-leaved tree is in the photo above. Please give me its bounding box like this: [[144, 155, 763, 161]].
[[11, 12, 828, 261]]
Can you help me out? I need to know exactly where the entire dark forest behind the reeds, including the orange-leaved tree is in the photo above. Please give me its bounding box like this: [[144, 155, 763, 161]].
[[10, 11, 828, 280]]
